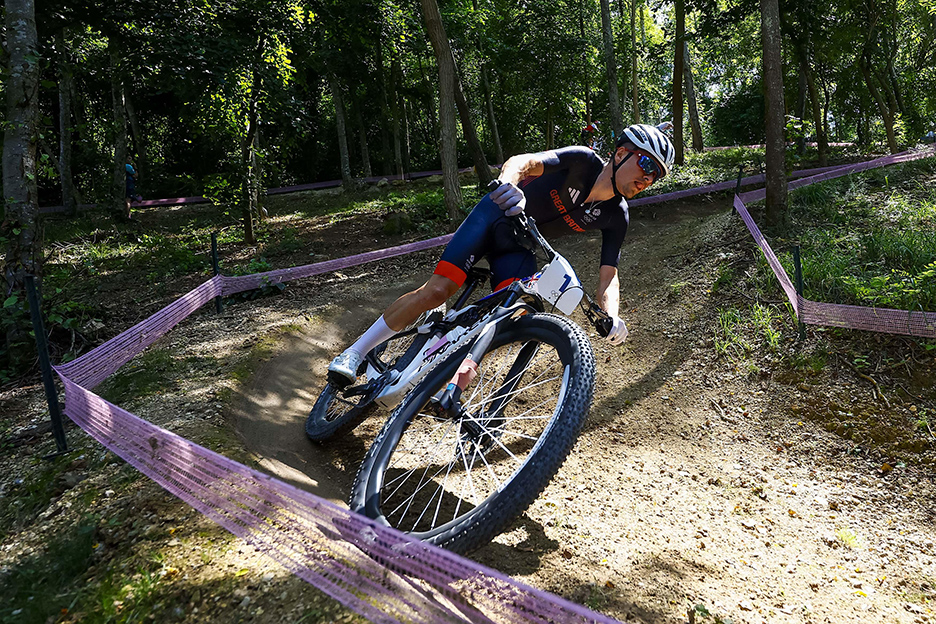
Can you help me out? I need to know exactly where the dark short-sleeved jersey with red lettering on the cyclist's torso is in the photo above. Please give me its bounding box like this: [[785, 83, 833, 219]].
[[520, 146, 629, 267]]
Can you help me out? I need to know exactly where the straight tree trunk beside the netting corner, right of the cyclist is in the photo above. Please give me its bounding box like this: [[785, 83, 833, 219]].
[[760, 0, 788, 227]]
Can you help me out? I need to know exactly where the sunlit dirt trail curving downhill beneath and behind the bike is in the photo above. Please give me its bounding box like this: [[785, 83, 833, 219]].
[[229, 203, 936, 624]]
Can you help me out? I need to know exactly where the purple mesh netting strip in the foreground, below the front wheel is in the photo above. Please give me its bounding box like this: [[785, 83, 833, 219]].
[[59, 371, 628, 624]]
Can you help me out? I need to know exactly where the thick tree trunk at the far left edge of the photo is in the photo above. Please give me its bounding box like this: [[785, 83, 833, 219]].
[[0, 0, 42, 314]]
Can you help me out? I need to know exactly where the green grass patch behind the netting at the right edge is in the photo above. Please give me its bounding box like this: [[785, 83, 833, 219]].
[[781, 158, 936, 311]]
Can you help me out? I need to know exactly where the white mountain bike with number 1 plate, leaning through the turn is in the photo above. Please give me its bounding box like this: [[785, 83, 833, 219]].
[[306, 183, 611, 553]]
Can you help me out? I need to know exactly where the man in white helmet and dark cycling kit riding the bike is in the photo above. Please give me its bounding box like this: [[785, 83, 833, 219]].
[[328, 124, 675, 384]]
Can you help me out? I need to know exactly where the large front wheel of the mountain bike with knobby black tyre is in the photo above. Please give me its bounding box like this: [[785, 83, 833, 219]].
[[350, 314, 595, 553]]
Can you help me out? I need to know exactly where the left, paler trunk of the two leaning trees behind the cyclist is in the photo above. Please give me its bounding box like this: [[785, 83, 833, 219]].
[[420, 0, 461, 223]]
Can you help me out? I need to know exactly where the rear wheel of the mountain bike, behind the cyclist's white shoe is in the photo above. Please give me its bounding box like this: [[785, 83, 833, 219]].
[[305, 304, 445, 442]]
